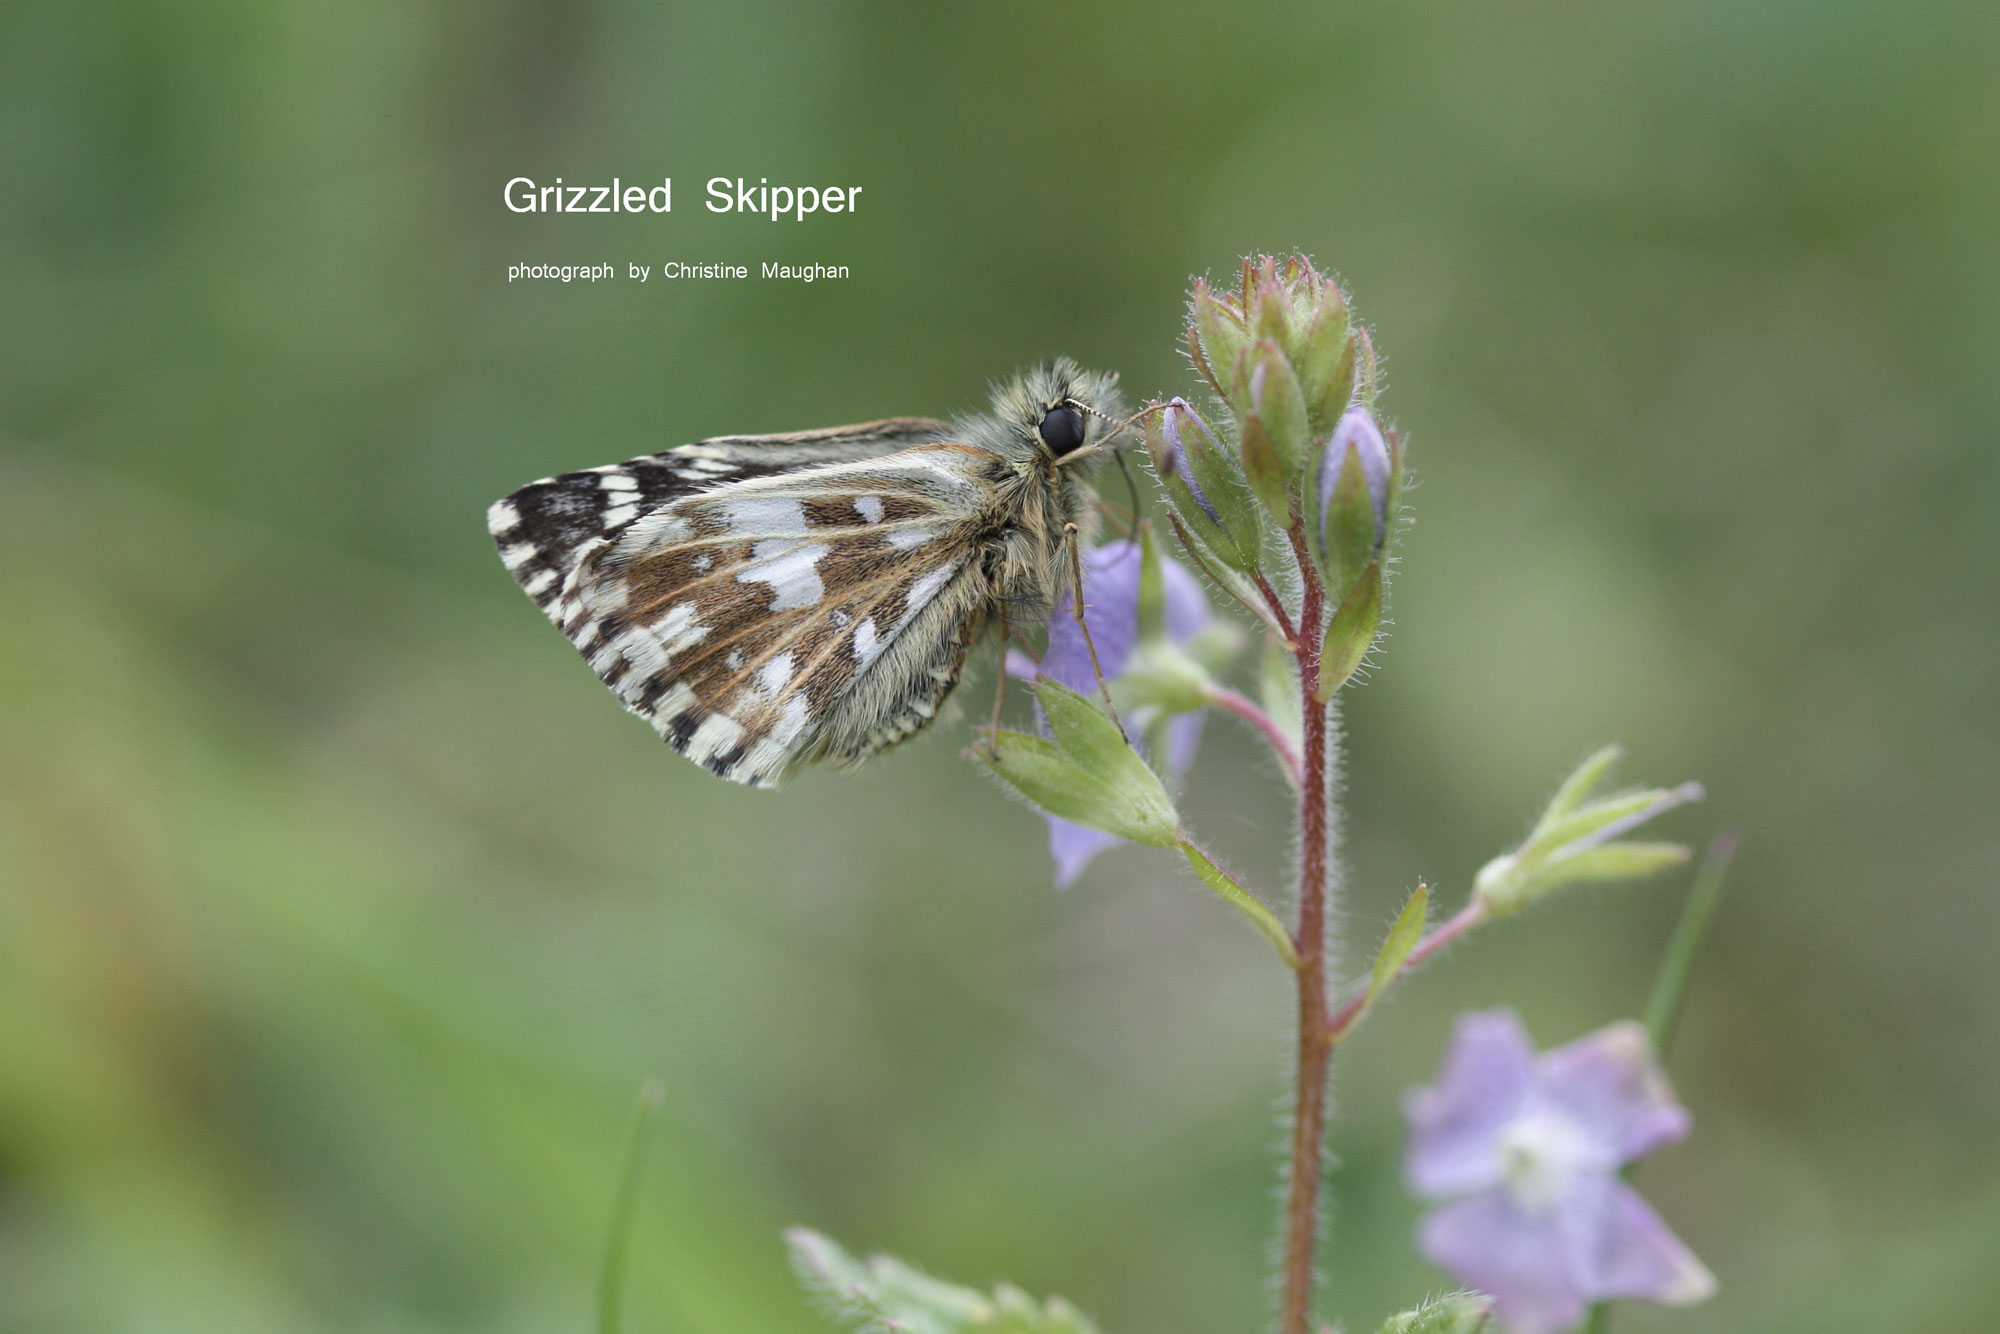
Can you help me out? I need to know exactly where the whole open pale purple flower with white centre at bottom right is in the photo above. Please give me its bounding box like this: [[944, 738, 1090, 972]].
[[1404, 1010, 1716, 1334]]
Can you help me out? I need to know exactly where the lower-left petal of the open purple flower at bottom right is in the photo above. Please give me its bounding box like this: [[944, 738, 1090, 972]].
[[1416, 1188, 1590, 1334]]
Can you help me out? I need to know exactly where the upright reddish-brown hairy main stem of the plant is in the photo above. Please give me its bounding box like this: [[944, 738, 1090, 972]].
[[1266, 520, 1334, 1334]]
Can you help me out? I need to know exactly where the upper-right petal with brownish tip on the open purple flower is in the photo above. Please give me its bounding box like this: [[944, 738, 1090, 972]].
[[1534, 1020, 1692, 1166]]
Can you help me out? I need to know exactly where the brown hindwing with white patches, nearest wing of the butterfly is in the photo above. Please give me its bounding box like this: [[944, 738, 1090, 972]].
[[546, 442, 1006, 786]]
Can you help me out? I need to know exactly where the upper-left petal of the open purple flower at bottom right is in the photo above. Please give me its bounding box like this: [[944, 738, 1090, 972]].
[[1404, 1010, 1534, 1200]]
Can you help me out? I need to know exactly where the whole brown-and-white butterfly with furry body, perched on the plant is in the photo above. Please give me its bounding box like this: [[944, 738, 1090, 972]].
[[488, 358, 1122, 788]]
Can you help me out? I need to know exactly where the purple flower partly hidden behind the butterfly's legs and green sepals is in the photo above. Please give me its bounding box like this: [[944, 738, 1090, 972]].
[[1008, 542, 1208, 888]]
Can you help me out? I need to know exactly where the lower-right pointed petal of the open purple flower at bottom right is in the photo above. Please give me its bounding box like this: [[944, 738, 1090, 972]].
[[1556, 1174, 1716, 1306]]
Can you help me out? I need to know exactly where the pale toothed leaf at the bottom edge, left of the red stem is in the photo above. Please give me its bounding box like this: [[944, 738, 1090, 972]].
[[784, 1228, 1098, 1334]]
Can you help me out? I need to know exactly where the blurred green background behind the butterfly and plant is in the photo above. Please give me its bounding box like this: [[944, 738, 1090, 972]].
[[0, 0, 2000, 1334]]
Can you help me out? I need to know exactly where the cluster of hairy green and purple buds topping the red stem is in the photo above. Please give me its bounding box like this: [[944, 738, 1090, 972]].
[[1148, 256, 1402, 694]]
